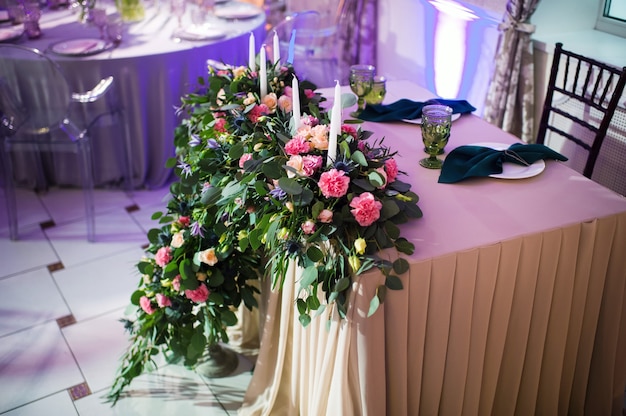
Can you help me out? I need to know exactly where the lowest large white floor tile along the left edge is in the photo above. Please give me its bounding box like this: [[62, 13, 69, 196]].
[[0, 322, 84, 412]]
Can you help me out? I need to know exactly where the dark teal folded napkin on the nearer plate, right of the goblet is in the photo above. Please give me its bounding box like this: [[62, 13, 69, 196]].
[[439, 143, 567, 183]]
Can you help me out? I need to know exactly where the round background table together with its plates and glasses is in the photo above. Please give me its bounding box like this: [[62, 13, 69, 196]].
[[0, 0, 265, 187]]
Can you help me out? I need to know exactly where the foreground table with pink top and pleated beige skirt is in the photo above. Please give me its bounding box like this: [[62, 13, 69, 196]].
[[240, 81, 626, 415]]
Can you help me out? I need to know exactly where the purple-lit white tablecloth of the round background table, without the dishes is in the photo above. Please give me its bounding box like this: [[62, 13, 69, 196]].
[[7, 0, 265, 187]]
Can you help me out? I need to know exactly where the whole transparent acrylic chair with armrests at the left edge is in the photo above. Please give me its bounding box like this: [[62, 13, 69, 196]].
[[0, 44, 131, 241]]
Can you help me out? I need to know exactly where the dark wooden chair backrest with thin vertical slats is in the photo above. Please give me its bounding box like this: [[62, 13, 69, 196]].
[[537, 43, 626, 178]]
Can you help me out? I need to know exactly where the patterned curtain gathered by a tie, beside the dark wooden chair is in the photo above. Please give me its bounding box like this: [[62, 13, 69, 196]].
[[484, 0, 539, 142]]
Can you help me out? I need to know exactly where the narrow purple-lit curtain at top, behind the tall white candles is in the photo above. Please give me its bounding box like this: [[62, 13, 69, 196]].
[[337, 0, 378, 84]]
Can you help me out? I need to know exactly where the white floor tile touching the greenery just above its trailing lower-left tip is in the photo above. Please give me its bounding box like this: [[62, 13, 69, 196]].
[[62, 309, 129, 392]]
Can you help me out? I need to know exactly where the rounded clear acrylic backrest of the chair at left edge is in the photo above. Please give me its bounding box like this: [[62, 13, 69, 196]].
[[0, 44, 72, 135]]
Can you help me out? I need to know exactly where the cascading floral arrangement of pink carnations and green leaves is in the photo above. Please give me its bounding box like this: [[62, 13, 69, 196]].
[[109, 57, 422, 401]]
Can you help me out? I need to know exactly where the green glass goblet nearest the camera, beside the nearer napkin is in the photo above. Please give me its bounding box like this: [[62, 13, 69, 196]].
[[420, 104, 452, 169]]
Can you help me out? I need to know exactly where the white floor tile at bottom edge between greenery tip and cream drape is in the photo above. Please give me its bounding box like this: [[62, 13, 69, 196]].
[[75, 365, 228, 416]]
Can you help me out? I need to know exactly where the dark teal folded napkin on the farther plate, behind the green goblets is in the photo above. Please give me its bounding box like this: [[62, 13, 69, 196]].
[[359, 98, 476, 121]]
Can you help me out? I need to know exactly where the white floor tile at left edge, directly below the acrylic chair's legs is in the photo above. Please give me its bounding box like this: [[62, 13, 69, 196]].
[[0, 226, 59, 278]]
